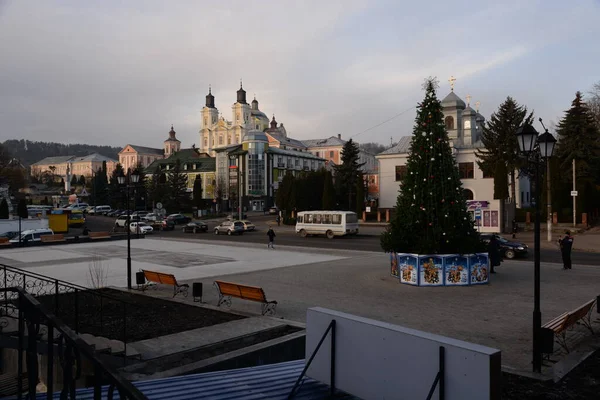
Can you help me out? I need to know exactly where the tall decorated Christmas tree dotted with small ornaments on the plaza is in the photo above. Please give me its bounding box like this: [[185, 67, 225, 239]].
[[381, 79, 482, 254]]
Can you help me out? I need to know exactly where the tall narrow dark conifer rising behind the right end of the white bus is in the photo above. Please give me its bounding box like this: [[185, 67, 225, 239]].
[[335, 139, 364, 211]]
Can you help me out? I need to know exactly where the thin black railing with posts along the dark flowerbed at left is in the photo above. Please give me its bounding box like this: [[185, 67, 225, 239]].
[[0, 264, 129, 360]]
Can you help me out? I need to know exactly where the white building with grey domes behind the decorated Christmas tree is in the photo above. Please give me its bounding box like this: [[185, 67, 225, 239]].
[[376, 87, 530, 232]]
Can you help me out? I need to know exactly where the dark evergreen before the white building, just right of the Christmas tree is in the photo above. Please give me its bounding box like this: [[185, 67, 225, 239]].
[[476, 97, 533, 204]]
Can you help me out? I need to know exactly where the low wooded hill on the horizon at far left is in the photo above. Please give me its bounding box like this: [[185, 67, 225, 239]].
[[3, 139, 121, 166]]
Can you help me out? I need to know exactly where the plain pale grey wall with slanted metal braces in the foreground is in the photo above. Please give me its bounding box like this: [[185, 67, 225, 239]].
[[306, 308, 502, 400]]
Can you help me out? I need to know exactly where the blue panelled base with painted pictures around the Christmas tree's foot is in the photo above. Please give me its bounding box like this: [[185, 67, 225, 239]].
[[390, 253, 490, 286]]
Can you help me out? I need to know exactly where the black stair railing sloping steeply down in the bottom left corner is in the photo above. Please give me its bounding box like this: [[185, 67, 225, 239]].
[[0, 287, 147, 400]]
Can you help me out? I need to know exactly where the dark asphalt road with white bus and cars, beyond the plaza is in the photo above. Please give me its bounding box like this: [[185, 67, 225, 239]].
[[86, 214, 600, 266]]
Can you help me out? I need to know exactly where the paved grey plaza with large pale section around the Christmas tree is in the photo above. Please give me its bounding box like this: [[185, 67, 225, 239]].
[[0, 239, 600, 371]]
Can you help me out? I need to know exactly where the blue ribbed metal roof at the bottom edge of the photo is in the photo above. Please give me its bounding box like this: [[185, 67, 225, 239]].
[[39, 360, 358, 400]]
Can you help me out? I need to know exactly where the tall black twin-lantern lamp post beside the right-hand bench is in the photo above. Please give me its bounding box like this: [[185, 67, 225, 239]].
[[516, 124, 556, 372]]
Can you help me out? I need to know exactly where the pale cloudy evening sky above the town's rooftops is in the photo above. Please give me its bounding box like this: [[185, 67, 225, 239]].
[[0, 0, 600, 147]]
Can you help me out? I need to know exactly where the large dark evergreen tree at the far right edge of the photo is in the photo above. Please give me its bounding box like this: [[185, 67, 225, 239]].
[[553, 92, 600, 216]]
